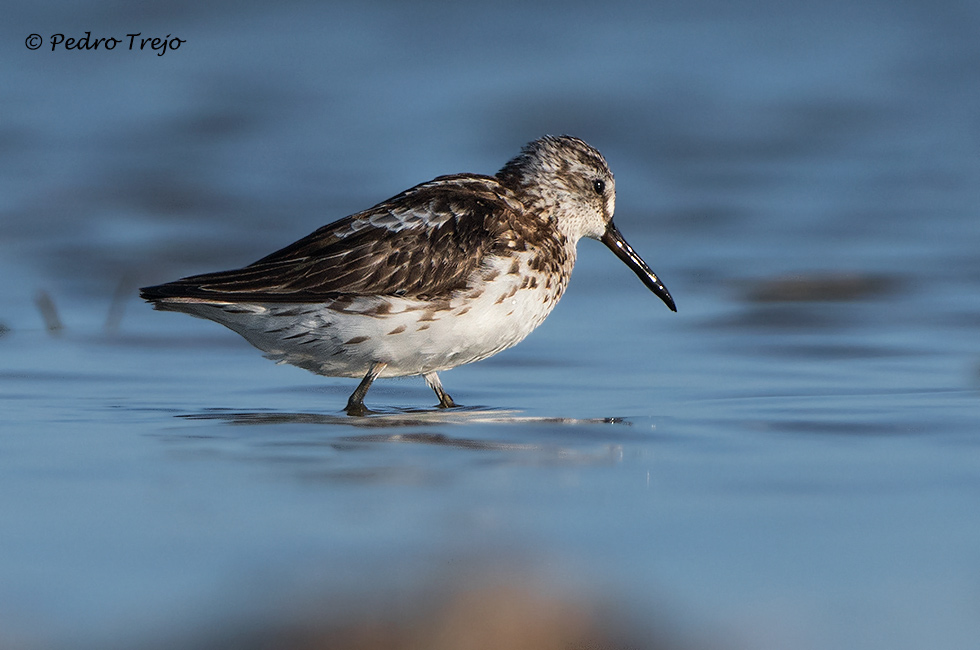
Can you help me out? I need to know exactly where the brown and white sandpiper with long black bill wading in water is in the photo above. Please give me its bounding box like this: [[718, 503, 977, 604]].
[[140, 136, 676, 415]]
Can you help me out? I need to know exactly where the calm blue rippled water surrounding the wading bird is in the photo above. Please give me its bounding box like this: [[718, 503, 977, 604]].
[[0, 0, 980, 649]]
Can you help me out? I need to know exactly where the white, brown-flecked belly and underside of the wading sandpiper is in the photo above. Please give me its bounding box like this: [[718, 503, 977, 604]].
[[171, 251, 570, 377]]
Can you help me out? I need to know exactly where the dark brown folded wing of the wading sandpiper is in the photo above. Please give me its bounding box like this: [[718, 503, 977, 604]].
[[140, 174, 519, 302]]
